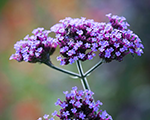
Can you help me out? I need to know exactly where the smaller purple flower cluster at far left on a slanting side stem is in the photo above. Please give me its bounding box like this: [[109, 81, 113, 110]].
[[10, 28, 57, 63]]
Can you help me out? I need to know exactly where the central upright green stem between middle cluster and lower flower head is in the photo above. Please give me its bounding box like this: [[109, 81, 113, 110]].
[[76, 60, 90, 90]]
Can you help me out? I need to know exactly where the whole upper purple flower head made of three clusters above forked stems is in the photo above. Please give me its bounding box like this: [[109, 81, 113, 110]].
[[10, 14, 144, 65]]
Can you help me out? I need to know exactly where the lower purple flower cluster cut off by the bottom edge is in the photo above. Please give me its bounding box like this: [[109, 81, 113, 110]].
[[38, 87, 112, 120]]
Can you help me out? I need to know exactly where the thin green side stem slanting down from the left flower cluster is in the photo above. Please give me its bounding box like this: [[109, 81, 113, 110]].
[[44, 62, 81, 78]]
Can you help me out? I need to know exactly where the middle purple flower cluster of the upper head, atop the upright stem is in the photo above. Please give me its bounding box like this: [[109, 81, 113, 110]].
[[51, 17, 99, 65]]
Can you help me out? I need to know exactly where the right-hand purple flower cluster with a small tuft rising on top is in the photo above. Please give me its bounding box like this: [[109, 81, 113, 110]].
[[96, 14, 144, 62]]
